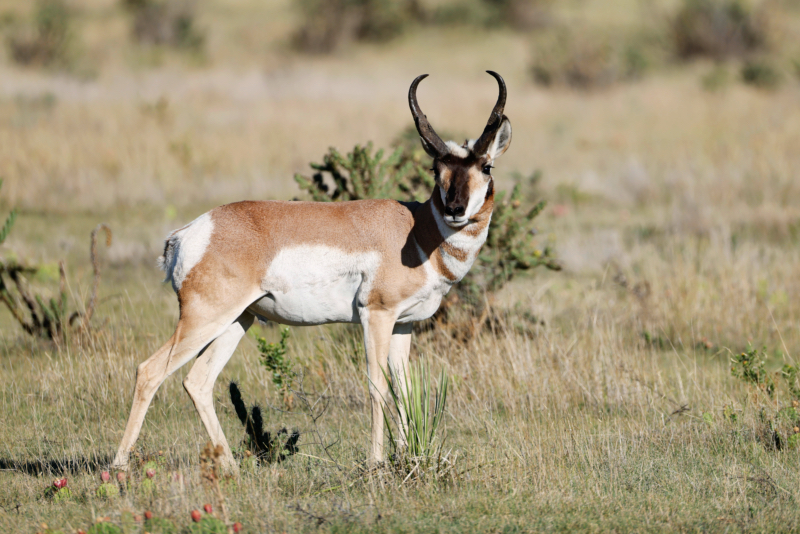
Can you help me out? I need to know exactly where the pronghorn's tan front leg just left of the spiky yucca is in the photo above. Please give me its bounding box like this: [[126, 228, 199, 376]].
[[361, 310, 396, 464]]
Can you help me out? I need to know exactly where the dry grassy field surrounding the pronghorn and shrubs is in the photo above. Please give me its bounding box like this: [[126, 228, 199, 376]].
[[0, 0, 800, 533]]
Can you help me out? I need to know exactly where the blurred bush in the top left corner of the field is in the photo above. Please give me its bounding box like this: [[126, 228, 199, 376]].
[[5, 0, 74, 66]]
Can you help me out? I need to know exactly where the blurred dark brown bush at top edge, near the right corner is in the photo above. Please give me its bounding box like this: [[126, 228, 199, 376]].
[[672, 0, 769, 59]]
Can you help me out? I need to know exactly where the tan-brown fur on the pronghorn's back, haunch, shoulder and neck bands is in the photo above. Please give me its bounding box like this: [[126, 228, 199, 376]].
[[178, 191, 493, 312]]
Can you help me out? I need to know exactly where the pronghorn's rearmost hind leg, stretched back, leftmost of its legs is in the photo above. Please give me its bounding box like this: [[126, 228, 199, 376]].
[[112, 304, 253, 469]]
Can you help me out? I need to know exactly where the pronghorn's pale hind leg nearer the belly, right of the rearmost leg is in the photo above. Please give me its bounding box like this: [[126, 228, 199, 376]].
[[183, 312, 254, 469]]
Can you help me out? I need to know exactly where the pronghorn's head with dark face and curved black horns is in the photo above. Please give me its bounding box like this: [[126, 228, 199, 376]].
[[408, 70, 511, 228]]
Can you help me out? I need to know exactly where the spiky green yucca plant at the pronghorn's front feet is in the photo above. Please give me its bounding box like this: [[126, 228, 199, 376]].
[[383, 363, 448, 475]]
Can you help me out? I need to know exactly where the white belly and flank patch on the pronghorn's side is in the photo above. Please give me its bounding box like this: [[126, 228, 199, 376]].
[[248, 245, 380, 326]]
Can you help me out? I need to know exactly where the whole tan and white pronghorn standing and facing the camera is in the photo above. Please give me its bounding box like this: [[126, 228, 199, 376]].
[[114, 71, 511, 469]]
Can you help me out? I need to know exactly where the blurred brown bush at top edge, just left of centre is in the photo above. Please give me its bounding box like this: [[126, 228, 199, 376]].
[[293, 0, 423, 53]]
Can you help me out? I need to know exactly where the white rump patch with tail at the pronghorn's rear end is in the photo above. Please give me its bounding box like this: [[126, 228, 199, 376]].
[[158, 213, 214, 292]]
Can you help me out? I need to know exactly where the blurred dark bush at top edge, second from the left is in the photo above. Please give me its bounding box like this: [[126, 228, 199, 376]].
[[122, 0, 206, 52]]
